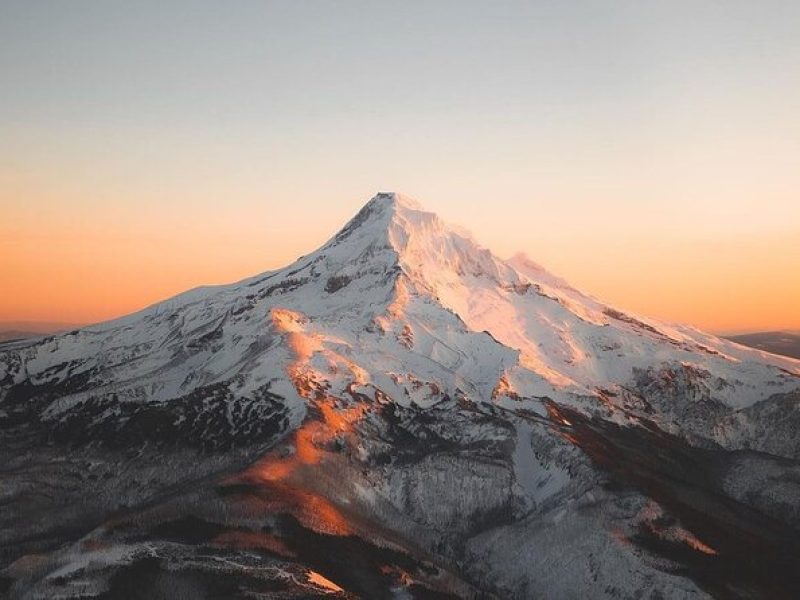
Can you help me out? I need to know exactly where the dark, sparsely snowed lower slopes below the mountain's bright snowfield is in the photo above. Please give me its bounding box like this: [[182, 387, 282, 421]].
[[2, 376, 800, 598]]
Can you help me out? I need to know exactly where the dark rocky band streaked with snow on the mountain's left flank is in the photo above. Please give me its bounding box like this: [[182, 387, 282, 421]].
[[0, 372, 288, 451]]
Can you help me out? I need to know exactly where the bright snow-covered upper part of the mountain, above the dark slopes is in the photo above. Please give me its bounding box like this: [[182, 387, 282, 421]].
[[0, 193, 800, 450]]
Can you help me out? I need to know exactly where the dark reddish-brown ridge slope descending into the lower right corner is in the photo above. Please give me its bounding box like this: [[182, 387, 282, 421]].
[[548, 409, 800, 598]]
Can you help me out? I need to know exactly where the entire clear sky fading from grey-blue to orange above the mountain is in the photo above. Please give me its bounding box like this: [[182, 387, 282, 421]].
[[0, 0, 800, 333]]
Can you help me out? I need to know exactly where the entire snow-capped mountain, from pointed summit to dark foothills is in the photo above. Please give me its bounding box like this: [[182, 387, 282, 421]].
[[0, 193, 800, 598]]
